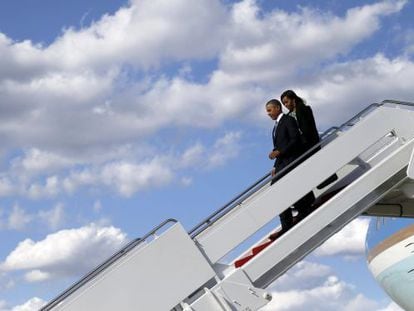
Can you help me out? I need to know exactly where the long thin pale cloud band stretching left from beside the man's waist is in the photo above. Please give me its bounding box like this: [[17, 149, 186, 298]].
[[0, 131, 242, 200]]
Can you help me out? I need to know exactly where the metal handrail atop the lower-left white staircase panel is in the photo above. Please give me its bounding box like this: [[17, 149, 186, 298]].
[[40, 218, 178, 311]]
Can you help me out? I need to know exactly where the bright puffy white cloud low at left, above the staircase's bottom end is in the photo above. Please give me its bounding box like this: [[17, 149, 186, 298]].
[[0, 224, 126, 282]]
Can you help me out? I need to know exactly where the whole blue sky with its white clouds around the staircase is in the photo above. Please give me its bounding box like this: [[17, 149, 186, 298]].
[[0, 0, 414, 311]]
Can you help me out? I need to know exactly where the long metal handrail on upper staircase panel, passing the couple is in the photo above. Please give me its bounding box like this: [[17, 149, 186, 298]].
[[188, 103, 383, 239]]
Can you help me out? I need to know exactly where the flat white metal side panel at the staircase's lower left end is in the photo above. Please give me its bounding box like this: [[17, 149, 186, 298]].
[[50, 223, 215, 311]]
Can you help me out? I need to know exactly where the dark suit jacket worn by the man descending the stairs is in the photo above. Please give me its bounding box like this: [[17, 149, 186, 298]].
[[273, 115, 303, 174]]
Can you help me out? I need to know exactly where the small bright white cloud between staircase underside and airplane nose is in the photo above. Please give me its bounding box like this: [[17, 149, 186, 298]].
[[314, 218, 370, 257]]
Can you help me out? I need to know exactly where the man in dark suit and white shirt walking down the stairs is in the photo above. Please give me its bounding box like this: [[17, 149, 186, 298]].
[[266, 99, 303, 240]]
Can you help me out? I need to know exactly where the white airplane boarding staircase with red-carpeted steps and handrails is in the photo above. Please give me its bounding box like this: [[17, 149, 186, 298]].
[[41, 100, 414, 311]]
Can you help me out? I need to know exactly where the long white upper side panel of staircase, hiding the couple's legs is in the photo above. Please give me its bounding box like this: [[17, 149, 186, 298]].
[[196, 107, 414, 263]]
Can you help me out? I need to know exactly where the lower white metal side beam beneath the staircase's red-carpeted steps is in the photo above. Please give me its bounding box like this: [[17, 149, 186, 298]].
[[242, 141, 414, 285]]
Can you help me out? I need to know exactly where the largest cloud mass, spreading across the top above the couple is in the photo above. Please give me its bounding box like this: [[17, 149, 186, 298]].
[[0, 0, 405, 161]]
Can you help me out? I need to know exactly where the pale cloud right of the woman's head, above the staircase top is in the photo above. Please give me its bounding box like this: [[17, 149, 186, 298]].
[[299, 54, 414, 127]]
